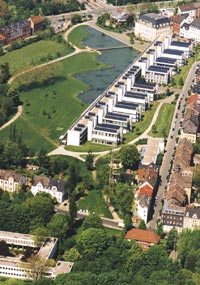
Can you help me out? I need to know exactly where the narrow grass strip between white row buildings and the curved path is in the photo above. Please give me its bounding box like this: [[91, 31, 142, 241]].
[[124, 102, 159, 143]]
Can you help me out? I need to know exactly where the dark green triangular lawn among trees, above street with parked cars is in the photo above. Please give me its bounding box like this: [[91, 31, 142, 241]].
[[78, 190, 113, 219]]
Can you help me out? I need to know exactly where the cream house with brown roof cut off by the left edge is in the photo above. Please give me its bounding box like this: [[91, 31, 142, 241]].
[[0, 169, 26, 193]]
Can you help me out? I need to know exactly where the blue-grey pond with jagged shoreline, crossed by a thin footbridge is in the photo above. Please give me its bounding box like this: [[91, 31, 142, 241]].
[[76, 27, 138, 104]]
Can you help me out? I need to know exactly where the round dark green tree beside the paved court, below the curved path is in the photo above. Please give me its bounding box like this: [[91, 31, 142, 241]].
[[119, 145, 140, 170]]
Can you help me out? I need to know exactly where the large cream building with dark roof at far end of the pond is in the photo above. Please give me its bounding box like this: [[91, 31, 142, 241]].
[[135, 13, 171, 41]]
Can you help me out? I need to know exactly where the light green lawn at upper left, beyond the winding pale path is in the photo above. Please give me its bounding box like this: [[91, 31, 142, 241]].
[[1, 40, 73, 74]]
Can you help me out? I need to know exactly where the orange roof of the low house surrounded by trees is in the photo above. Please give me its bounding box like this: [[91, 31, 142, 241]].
[[125, 229, 160, 244]]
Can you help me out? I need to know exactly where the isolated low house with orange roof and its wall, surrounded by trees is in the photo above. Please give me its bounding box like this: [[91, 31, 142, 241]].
[[125, 226, 160, 250]]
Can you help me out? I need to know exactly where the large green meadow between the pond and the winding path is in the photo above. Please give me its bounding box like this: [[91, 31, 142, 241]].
[[0, 53, 108, 151]]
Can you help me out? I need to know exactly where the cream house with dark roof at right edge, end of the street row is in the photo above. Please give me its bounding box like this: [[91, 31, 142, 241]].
[[183, 207, 200, 230]]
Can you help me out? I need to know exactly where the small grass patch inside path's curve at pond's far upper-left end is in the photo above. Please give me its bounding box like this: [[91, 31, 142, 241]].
[[68, 25, 90, 48]]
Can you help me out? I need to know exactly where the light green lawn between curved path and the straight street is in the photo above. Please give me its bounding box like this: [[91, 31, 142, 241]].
[[149, 103, 175, 138]]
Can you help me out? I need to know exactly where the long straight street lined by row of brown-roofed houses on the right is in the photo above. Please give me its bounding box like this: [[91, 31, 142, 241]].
[[148, 62, 199, 230]]
